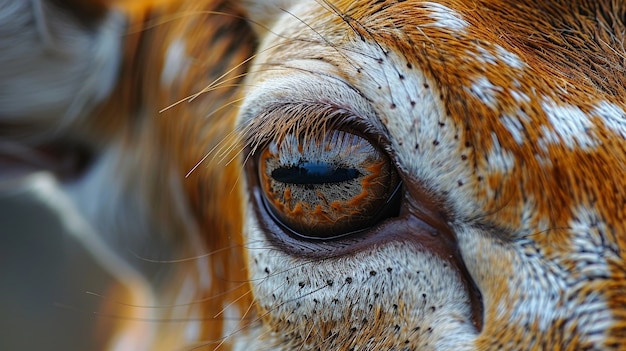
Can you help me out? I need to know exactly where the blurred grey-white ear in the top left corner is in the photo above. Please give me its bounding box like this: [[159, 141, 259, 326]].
[[0, 0, 125, 132]]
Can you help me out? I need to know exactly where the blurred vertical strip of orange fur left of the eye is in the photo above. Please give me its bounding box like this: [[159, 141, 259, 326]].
[[91, 2, 252, 349]]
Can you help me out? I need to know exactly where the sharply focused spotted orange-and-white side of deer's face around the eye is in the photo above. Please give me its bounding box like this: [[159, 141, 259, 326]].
[[233, 1, 626, 350]]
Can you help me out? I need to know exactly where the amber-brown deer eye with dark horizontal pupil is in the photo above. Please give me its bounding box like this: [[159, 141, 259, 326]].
[[258, 130, 400, 240]]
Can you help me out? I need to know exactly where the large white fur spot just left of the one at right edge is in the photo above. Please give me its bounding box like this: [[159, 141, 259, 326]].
[[539, 100, 598, 150]]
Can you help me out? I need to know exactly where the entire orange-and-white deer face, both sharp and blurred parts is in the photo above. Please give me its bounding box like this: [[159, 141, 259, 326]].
[[0, 0, 626, 351]]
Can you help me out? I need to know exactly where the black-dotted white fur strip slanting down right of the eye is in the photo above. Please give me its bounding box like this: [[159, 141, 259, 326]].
[[344, 43, 476, 218]]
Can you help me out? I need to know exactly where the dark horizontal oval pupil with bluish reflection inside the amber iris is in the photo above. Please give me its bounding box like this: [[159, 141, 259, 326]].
[[272, 162, 361, 184]]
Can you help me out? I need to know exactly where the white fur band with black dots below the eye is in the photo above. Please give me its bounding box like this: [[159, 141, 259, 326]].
[[246, 218, 475, 351]]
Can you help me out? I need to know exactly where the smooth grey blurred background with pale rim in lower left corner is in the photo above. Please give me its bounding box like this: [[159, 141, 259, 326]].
[[0, 172, 120, 351]]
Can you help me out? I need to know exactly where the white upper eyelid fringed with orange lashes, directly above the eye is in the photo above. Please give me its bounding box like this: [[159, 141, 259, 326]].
[[238, 71, 389, 151]]
